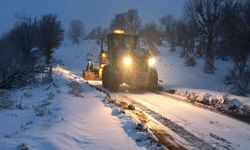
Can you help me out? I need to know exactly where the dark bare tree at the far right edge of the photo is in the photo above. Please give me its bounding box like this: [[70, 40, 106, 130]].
[[220, 0, 250, 95]]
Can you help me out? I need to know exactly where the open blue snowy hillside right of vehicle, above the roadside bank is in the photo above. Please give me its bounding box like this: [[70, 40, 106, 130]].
[[157, 46, 232, 91]]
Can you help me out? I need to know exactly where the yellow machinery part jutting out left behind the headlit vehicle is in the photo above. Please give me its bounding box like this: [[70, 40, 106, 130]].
[[82, 36, 108, 80]]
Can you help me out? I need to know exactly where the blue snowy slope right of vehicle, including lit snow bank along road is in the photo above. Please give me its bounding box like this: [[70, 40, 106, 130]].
[[156, 44, 250, 109]]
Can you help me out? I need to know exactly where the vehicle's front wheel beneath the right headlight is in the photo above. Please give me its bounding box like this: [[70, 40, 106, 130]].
[[148, 68, 158, 91]]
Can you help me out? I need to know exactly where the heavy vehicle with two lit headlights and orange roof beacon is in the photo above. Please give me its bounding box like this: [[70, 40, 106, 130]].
[[102, 30, 158, 91]]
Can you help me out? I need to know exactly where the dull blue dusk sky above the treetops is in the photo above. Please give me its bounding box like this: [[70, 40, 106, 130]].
[[0, 0, 185, 34]]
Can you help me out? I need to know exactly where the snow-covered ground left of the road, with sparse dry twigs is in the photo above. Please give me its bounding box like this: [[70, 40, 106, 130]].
[[0, 70, 147, 150]]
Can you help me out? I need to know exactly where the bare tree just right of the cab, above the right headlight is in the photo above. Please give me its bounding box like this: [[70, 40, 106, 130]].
[[140, 23, 162, 53]]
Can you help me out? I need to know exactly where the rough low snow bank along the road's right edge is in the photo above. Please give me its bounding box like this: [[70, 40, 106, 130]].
[[166, 89, 250, 122]]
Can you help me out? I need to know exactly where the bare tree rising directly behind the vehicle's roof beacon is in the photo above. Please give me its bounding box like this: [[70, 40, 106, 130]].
[[110, 9, 141, 34]]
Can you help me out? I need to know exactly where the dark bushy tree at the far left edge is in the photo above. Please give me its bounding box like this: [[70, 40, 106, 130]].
[[0, 14, 37, 86]]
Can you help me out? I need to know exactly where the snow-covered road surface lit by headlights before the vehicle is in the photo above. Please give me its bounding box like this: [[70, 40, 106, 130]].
[[111, 93, 250, 150]]
